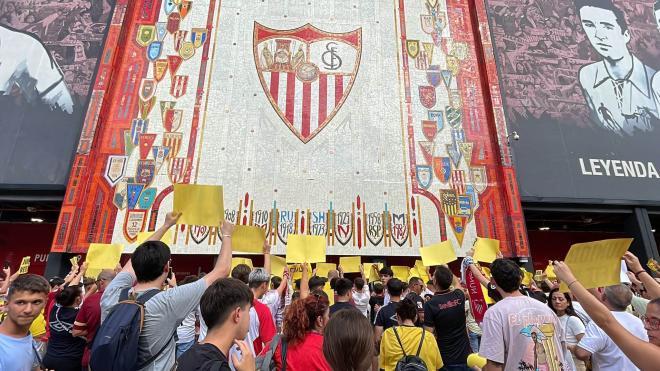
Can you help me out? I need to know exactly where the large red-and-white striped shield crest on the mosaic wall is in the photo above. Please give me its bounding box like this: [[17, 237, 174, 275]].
[[253, 22, 362, 143]]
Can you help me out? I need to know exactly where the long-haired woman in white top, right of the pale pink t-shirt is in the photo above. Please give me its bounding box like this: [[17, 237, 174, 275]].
[[548, 288, 587, 371]]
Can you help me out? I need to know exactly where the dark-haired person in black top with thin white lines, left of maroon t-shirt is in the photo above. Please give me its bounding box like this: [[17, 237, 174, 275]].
[[43, 285, 86, 371]]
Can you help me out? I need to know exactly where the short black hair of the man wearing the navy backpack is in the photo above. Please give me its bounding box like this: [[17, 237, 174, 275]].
[[131, 241, 170, 282]]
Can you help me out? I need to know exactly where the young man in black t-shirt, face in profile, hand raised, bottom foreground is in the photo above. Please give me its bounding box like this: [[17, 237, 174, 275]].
[[178, 278, 255, 371]]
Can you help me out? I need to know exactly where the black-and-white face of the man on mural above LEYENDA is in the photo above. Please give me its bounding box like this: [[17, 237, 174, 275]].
[[580, 6, 630, 61]]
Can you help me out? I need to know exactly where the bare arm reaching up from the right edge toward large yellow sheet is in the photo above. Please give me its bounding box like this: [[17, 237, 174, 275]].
[[553, 261, 660, 370]]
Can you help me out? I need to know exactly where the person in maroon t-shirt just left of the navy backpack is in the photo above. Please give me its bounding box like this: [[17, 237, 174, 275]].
[[72, 269, 115, 370]]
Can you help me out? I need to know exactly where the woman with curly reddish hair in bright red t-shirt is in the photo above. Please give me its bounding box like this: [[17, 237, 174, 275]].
[[271, 292, 331, 371]]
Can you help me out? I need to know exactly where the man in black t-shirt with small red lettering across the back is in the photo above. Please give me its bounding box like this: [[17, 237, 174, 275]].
[[424, 266, 472, 370]]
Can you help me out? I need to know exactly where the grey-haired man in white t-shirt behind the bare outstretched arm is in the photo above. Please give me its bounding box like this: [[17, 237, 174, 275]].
[[575, 284, 649, 371]]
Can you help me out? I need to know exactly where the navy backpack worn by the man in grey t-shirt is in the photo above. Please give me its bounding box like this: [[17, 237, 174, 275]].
[[89, 288, 176, 371]]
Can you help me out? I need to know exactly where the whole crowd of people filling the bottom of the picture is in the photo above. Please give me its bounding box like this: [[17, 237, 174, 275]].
[[0, 213, 660, 371]]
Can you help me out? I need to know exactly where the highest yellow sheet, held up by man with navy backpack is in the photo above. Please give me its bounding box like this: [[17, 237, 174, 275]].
[[172, 184, 225, 227]]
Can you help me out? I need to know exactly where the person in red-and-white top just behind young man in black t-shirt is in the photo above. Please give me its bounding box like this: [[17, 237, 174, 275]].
[[248, 268, 277, 354]]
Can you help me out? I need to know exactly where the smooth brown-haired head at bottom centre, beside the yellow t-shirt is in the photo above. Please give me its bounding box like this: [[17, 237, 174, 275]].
[[323, 309, 374, 371]]
